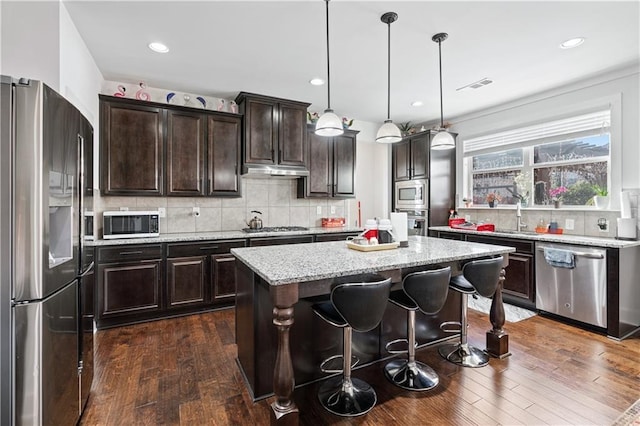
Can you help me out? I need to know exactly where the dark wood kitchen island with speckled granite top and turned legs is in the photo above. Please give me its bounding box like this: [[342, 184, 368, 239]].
[[231, 236, 514, 423]]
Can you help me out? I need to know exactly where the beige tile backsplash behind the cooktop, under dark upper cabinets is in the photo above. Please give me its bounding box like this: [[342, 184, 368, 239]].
[[94, 178, 350, 235]]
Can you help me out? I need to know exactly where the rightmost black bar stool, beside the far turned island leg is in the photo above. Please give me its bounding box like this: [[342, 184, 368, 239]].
[[438, 256, 503, 367]]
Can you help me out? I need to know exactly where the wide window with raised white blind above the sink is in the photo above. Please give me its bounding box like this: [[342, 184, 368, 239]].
[[464, 110, 611, 206]]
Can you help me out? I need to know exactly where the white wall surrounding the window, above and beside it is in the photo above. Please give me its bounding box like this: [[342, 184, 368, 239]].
[[451, 64, 640, 208]]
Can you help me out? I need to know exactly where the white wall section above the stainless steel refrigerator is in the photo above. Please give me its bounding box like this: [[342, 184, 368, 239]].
[[0, 1, 60, 91]]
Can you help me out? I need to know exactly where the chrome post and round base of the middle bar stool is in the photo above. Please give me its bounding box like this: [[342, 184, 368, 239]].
[[384, 310, 440, 391]]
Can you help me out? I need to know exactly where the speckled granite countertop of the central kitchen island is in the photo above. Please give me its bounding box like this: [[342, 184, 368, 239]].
[[231, 236, 515, 285]]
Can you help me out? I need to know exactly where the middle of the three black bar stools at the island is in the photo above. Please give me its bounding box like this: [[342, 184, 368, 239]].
[[384, 266, 451, 391]]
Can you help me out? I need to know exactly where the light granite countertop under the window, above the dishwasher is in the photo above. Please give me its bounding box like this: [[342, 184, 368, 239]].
[[429, 226, 640, 248]]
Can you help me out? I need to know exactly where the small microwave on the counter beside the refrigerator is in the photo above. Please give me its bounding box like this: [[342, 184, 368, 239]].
[[102, 211, 160, 240]]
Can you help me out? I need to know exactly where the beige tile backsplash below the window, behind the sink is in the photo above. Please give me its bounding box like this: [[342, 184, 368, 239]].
[[458, 189, 640, 237]]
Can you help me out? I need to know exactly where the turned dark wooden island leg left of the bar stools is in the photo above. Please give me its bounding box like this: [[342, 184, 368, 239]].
[[271, 284, 299, 425]]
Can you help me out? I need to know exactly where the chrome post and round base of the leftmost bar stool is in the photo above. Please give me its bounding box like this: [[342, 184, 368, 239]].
[[318, 327, 377, 417]]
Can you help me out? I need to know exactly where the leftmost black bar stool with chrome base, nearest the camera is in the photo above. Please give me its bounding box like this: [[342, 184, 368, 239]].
[[312, 274, 391, 417]]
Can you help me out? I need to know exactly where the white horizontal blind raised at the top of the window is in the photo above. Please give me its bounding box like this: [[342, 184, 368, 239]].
[[463, 110, 611, 154]]
